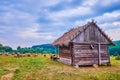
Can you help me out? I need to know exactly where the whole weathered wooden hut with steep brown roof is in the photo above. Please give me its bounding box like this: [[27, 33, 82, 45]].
[[52, 21, 114, 66]]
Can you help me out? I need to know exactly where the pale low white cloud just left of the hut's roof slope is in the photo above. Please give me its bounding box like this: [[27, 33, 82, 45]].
[[18, 24, 55, 40]]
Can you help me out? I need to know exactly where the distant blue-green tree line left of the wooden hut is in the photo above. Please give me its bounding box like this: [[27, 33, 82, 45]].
[[0, 44, 58, 54]]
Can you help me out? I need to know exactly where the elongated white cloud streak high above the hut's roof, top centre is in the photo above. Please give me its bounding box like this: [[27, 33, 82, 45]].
[[48, 6, 93, 20]]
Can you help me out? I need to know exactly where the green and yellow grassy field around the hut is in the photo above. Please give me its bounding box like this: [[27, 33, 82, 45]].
[[0, 55, 120, 80]]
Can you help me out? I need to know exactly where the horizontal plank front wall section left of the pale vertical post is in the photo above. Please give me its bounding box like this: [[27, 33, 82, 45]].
[[73, 44, 98, 65]]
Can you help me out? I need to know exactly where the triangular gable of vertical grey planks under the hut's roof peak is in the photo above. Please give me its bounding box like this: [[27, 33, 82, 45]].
[[72, 25, 109, 44]]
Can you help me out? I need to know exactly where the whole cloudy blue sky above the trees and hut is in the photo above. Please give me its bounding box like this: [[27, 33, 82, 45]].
[[0, 0, 120, 48]]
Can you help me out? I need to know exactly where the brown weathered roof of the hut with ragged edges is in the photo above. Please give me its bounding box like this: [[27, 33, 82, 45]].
[[52, 22, 114, 46]]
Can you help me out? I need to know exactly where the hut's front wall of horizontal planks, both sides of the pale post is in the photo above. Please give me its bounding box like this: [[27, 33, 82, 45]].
[[73, 44, 109, 65]]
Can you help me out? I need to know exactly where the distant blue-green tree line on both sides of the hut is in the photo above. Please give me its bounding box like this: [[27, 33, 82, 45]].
[[0, 41, 120, 56]]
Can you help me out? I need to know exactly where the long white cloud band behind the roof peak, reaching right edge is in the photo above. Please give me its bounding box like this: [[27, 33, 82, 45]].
[[75, 10, 120, 25]]
